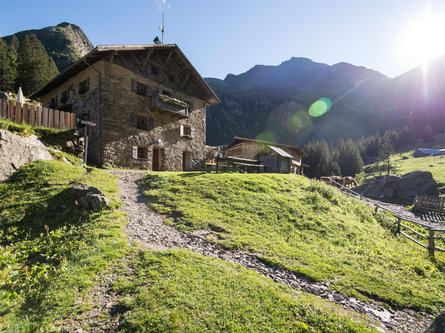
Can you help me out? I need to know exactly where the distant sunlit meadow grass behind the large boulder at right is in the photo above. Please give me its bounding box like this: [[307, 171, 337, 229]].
[[365, 150, 445, 195]]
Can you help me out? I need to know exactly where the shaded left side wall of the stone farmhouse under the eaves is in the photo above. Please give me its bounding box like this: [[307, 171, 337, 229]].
[[37, 61, 105, 164]]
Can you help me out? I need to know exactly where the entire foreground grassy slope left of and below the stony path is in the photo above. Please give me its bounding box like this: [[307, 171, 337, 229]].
[[0, 161, 376, 332]]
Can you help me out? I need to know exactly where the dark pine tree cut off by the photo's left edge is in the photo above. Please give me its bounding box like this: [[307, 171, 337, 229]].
[[0, 36, 19, 91]]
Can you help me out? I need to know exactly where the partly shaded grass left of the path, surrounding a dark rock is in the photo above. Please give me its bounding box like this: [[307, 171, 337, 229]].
[[0, 161, 128, 332]]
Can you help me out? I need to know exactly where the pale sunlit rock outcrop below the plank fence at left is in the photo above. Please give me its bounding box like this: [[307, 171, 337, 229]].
[[0, 129, 53, 182]]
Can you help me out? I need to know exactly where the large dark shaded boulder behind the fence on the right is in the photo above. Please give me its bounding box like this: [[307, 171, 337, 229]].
[[353, 171, 438, 200]]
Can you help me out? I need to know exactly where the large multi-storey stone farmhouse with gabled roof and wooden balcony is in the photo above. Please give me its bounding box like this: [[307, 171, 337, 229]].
[[31, 44, 220, 171]]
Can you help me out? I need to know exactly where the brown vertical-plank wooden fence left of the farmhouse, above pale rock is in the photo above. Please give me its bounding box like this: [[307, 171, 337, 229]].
[[0, 99, 76, 130]]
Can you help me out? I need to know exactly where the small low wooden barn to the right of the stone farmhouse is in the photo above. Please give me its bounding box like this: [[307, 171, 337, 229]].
[[227, 137, 308, 175]]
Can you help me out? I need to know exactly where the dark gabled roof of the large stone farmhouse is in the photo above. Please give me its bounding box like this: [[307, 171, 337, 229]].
[[30, 44, 221, 104]]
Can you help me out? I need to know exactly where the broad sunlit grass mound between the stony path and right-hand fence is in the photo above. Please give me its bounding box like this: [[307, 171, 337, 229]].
[[141, 173, 445, 312]]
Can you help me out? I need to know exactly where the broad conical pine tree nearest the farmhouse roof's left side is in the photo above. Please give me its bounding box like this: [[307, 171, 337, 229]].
[[16, 34, 58, 95]]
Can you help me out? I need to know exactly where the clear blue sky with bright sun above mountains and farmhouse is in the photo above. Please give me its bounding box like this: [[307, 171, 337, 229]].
[[0, 0, 445, 78]]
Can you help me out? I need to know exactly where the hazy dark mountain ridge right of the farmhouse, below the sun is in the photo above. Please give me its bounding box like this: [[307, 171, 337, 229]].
[[206, 57, 445, 145]]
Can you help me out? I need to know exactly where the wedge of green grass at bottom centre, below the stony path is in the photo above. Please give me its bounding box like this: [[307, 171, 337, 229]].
[[114, 250, 370, 332]]
